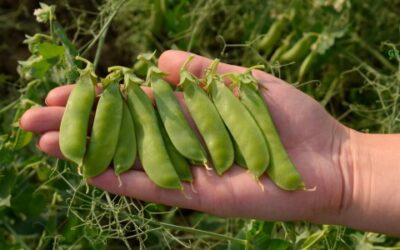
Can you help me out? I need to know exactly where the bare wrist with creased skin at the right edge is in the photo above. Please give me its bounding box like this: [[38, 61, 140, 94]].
[[338, 129, 400, 235]]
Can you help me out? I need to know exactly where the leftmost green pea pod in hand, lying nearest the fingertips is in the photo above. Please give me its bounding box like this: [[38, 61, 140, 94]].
[[60, 60, 96, 165]]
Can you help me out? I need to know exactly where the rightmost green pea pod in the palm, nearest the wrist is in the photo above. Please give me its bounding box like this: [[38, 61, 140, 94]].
[[239, 84, 305, 190]]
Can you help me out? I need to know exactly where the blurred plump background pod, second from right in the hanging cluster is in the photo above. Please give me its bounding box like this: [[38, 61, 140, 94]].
[[278, 33, 316, 62]]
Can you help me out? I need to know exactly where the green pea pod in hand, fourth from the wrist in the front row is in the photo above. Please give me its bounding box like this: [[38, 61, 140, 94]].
[[148, 67, 207, 165]]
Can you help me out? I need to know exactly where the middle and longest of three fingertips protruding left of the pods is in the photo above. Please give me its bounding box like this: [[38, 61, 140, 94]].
[[19, 107, 64, 133]]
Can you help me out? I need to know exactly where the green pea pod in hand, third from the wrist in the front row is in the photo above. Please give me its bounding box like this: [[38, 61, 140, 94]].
[[179, 64, 234, 175]]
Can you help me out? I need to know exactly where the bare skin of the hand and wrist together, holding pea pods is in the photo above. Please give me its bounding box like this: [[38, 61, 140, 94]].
[[20, 50, 400, 235]]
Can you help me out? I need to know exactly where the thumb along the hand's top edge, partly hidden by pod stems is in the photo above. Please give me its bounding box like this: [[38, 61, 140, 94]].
[[158, 50, 246, 84]]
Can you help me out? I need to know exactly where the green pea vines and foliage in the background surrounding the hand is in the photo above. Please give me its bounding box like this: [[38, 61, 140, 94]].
[[0, 0, 400, 249]]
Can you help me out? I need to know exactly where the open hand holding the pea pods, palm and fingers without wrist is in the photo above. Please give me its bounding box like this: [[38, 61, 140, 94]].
[[20, 51, 350, 223]]
